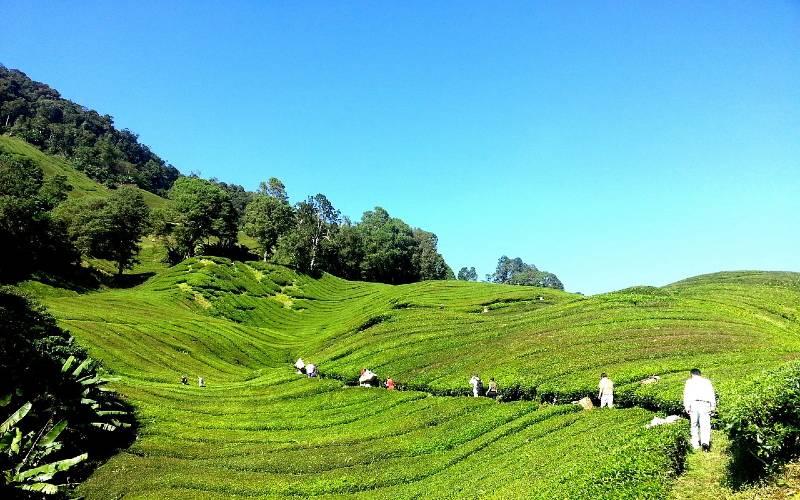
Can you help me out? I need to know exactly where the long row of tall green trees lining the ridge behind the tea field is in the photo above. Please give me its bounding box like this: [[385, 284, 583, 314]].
[[153, 177, 455, 283]]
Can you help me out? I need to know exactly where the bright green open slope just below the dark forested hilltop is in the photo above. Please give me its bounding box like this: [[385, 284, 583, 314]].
[[0, 135, 166, 208]]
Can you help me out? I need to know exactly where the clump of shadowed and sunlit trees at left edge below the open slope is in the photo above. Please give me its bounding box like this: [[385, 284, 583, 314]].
[[0, 153, 150, 281]]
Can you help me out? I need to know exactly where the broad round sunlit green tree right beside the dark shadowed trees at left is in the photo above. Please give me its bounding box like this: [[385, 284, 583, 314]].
[[58, 187, 150, 275]]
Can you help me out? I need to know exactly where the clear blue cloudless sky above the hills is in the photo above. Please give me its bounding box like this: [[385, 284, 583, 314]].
[[0, 0, 800, 293]]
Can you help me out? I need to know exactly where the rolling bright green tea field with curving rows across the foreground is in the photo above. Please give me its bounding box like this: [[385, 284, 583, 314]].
[[36, 258, 800, 498]]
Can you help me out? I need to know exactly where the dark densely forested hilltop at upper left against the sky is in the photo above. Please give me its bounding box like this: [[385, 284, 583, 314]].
[[0, 65, 180, 194]]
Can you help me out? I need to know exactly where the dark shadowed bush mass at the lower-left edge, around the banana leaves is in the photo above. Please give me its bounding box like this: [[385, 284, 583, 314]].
[[0, 288, 133, 498]]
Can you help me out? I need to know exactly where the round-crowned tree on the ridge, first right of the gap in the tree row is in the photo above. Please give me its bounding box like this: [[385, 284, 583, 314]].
[[243, 194, 295, 262]]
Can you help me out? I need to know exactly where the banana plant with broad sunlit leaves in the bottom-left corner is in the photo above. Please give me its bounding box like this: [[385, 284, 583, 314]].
[[0, 402, 88, 495]]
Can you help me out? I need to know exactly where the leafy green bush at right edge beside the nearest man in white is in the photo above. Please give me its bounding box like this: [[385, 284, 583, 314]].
[[723, 362, 800, 482]]
